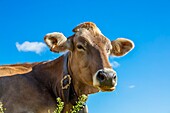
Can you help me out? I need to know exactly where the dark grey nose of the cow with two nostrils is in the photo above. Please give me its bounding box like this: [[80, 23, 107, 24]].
[[96, 70, 117, 87]]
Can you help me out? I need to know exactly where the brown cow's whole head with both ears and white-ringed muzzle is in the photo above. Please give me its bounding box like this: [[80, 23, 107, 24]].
[[44, 22, 134, 91]]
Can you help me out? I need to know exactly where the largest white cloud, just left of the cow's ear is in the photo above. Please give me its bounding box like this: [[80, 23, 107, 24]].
[[16, 41, 47, 54]]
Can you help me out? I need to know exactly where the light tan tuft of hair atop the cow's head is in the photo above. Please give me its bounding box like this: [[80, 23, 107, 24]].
[[73, 22, 102, 34]]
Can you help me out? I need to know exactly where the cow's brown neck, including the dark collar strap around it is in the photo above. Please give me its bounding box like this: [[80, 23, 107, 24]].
[[32, 53, 78, 104]]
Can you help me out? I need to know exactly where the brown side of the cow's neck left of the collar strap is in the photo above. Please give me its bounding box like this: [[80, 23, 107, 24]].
[[29, 56, 64, 99]]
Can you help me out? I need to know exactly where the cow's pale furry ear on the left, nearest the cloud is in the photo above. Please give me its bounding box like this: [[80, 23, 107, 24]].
[[44, 32, 72, 53]]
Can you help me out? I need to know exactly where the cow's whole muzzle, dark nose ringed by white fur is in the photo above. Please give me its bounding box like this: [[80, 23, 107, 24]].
[[93, 68, 117, 91]]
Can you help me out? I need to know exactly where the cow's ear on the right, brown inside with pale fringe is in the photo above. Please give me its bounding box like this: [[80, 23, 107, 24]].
[[111, 38, 134, 56]]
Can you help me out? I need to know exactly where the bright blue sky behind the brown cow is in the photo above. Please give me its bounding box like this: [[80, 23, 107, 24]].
[[0, 0, 170, 113]]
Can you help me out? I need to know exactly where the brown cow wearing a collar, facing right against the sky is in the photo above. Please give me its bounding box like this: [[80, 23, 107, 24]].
[[0, 22, 134, 113]]
